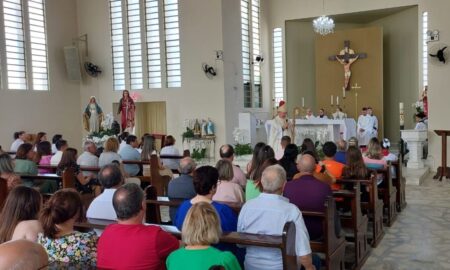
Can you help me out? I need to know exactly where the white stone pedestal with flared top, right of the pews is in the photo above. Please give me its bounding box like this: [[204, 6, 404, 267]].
[[401, 129, 428, 169]]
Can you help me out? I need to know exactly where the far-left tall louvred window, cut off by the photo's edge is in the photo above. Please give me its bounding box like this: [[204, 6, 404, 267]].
[[0, 0, 49, 90]]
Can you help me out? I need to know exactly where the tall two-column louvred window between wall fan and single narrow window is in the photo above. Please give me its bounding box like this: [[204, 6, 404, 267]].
[[241, 0, 262, 108]]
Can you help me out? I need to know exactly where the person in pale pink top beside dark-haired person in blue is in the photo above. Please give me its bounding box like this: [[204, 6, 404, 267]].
[[213, 159, 244, 203]]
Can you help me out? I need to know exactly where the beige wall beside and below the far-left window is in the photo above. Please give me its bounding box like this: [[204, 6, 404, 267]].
[[0, 0, 81, 150]]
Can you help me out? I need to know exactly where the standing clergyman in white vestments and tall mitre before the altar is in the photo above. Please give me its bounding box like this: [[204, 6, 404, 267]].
[[265, 100, 294, 153]]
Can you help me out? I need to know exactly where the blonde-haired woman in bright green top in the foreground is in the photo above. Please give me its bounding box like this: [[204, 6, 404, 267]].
[[166, 202, 241, 270]]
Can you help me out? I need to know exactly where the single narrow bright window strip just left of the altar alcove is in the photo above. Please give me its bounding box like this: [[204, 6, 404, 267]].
[[272, 28, 284, 107]]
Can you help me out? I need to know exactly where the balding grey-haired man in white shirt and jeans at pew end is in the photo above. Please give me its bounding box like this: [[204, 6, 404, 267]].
[[237, 165, 315, 270]]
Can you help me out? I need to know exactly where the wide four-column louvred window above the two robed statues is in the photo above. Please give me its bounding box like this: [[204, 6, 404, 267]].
[[109, 0, 181, 90]]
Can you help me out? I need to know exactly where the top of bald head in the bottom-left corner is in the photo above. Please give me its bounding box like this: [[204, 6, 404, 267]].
[[0, 240, 48, 270]]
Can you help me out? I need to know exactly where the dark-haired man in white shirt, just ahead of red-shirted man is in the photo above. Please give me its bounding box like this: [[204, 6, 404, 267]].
[[86, 164, 124, 220]]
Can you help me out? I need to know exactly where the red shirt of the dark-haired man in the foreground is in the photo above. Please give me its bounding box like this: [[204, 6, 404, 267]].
[[97, 224, 179, 270]]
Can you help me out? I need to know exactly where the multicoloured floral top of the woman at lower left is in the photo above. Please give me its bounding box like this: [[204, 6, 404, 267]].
[[37, 232, 98, 266]]
